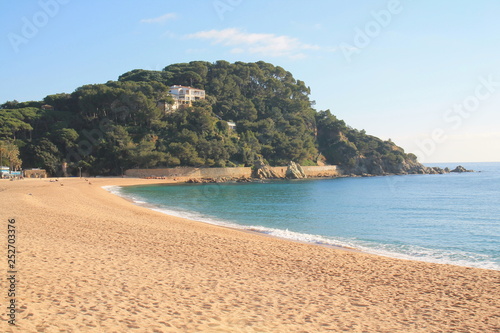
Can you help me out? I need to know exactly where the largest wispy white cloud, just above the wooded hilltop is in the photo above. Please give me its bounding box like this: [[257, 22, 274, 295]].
[[185, 28, 321, 59]]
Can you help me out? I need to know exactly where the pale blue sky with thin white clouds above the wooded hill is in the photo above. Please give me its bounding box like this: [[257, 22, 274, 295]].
[[0, 0, 500, 163]]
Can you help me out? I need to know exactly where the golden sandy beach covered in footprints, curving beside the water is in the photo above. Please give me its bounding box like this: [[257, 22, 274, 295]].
[[0, 178, 500, 332]]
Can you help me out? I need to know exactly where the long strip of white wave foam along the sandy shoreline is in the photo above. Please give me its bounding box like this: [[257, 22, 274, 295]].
[[102, 186, 500, 270]]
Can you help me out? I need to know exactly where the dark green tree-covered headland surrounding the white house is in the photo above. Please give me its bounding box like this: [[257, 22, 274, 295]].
[[0, 61, 426, 176]]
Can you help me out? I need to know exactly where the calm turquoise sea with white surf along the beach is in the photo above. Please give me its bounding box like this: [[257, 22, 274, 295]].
[[103, 163, 500, 270]]
